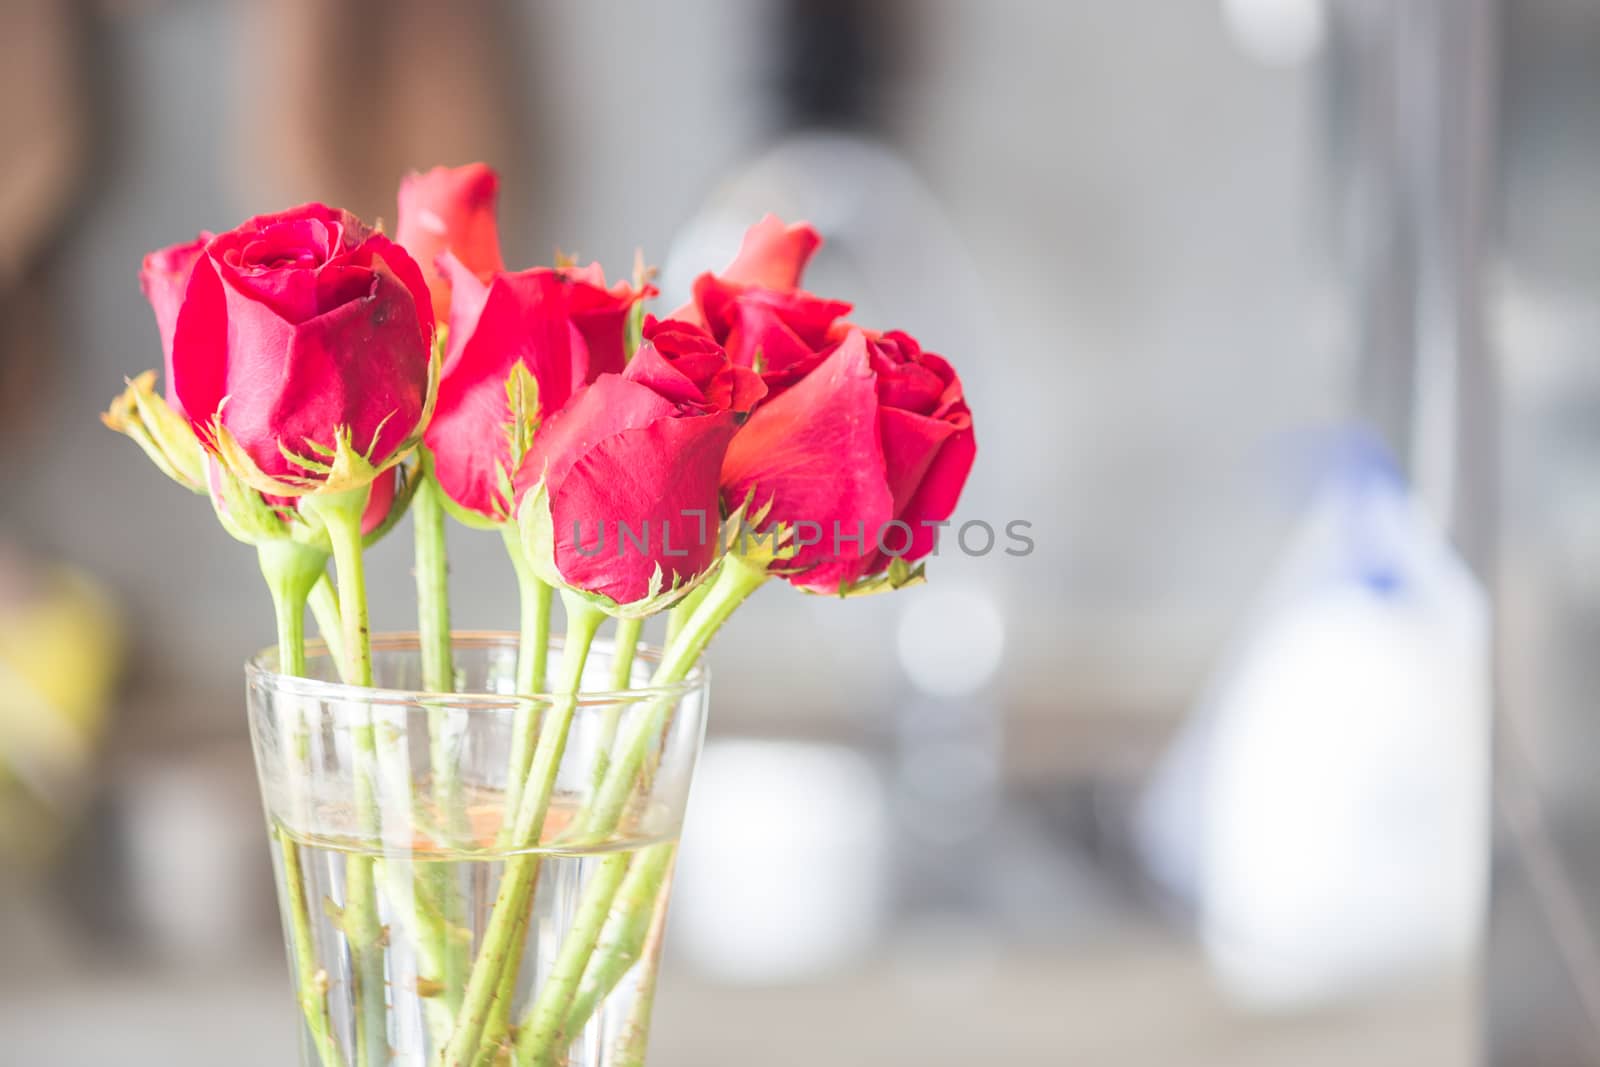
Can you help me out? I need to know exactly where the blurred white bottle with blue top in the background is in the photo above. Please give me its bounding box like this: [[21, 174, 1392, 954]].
[[1141, 443, 1491, 1008]]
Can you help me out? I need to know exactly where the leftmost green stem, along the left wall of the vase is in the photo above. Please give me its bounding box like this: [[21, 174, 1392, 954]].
[[256, 539, 344, 1067]]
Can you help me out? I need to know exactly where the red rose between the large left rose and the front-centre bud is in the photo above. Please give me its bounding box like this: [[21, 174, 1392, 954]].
[[422, 254, 643, 522]]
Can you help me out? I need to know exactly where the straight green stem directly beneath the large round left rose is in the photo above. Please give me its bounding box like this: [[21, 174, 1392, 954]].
[[299, 486, 389, 1067]]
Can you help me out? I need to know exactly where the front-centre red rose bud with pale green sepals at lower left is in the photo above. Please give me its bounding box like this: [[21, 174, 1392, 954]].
[[517, 320, 763, 617]]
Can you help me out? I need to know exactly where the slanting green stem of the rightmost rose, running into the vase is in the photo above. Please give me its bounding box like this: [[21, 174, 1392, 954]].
[[517, 555, 766, 1067]]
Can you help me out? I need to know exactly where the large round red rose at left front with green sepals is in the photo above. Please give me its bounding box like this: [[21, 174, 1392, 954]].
[[171, 203, 434, 496]]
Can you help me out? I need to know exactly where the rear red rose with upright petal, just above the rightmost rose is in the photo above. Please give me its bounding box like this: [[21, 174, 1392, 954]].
[[674, 214, 850, 400]]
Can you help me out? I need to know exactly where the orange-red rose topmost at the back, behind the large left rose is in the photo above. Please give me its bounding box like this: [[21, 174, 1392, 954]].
[[395, 163, 506, 323]]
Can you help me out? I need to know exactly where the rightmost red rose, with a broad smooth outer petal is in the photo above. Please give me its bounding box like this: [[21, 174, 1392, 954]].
[[722, 326, 976, 595]]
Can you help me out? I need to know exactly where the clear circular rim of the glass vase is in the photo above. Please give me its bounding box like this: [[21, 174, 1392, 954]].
[[245, 630, 710, 710]]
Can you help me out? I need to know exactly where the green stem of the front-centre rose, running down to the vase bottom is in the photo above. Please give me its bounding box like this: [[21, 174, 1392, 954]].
[[443, 590, 605, 1067]]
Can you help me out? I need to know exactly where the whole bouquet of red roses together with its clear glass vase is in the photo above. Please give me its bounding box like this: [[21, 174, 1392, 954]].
[[104, 165, 974, 1067]]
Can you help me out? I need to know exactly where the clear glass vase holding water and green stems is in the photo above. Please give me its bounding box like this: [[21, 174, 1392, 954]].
[[246, 633, 707, 1067]]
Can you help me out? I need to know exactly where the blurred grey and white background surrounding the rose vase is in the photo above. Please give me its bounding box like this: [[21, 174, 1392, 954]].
[[0, 0, 1600, 1067]]
